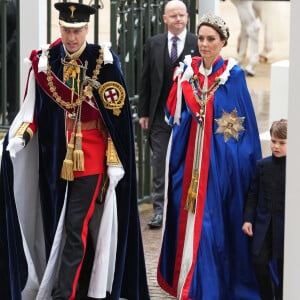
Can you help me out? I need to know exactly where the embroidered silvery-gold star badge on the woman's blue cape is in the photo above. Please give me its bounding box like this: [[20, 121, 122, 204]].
[[215, 108, 245, 143]]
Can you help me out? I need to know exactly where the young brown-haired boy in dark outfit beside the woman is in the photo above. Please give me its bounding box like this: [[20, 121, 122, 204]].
[[242, 119, 287, 300]]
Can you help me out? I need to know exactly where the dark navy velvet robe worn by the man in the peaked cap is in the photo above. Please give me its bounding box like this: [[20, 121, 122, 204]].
[[0, 41, 149, 300]]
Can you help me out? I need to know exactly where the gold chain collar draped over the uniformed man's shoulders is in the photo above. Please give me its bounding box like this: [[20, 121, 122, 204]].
[[47, 48, 103, 109]]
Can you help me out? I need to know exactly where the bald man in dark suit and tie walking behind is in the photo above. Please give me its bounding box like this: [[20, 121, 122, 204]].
[[138, 0, 199, 229]]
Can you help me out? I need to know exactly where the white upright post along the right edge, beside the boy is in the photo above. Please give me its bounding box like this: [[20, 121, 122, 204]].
[[283, 0, 300, 300]]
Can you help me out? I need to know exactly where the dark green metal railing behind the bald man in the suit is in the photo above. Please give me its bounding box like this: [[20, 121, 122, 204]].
[[110, 0, 196, 202]]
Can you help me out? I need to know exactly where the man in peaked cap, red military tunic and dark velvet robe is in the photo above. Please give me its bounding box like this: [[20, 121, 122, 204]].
[[0, 2, 149, 300]]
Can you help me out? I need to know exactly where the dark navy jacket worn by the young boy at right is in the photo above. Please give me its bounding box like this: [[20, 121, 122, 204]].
[[244, 156, 286, 258]]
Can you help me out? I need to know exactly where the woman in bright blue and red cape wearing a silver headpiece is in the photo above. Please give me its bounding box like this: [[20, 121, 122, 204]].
[[158, 14, 261, 300]]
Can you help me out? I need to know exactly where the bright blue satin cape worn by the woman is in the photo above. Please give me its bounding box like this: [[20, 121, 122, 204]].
[[158, 58, 261, 300]]
